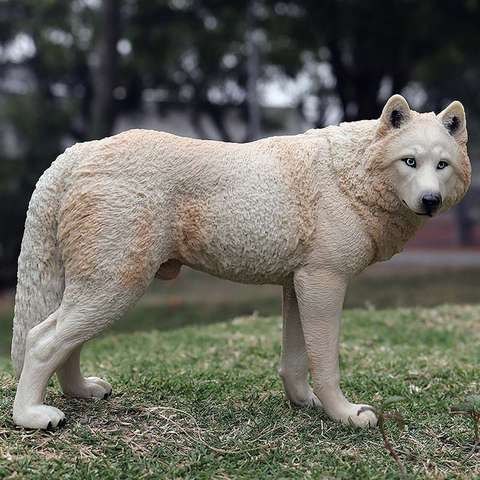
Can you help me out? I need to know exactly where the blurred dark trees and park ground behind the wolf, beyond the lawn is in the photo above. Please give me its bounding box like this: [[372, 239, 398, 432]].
[[0, 0, 480, 353]]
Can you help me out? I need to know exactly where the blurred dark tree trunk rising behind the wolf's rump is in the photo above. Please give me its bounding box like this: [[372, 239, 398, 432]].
[[90, 0, 120, 138]]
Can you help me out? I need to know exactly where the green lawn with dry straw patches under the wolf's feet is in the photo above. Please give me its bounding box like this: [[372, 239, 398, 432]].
[[0, 306, 480, 479]]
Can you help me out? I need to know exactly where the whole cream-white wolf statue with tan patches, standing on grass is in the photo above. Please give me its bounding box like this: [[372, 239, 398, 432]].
[[12, 95, 470, 430]]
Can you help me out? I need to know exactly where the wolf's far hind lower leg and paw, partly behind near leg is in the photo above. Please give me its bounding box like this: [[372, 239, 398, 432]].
[[57, 345, 112, 400]]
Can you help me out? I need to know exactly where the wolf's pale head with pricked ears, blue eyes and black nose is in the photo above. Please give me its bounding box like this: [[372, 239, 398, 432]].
[[374, 95, 471, 217]]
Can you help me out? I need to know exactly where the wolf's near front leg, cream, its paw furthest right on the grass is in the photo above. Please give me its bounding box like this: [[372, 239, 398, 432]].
[[294, 269, 377, 427]]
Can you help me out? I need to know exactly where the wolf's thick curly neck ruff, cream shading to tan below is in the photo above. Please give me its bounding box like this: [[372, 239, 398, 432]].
[[328, 120, 425, 264]]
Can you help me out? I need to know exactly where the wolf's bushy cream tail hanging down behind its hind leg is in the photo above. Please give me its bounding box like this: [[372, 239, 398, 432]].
[[12, 155, 66, 377]]
